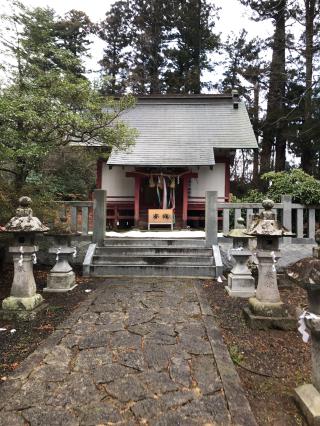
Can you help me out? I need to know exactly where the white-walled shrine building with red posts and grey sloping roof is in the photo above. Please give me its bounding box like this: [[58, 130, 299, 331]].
[[97, 92, 257, 228]]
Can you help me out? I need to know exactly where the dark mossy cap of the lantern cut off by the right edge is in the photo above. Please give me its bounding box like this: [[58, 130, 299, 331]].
[[287, 257, 320, 290]]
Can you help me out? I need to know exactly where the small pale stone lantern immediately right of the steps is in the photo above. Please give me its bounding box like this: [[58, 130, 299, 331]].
[[225, 217, 255, 298]]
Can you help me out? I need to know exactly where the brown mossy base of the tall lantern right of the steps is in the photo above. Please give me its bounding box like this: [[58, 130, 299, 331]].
[[243, 297, 297, 330]]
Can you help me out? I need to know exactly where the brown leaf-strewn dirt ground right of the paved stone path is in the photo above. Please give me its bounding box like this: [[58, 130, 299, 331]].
[[205, 281, 311, 426]]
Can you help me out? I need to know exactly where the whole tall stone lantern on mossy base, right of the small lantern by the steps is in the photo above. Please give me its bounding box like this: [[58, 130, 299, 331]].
[[244, 200, 296, 330]]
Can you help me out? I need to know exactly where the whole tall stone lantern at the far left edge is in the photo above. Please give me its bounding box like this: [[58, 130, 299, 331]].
[[0, 197, 49, 319]]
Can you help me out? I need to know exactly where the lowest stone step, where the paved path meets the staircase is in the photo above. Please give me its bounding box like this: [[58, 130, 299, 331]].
[[90, 264, 216, 278]]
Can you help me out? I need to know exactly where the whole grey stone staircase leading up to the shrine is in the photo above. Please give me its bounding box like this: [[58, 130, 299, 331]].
[[90, 238, 216, 278]]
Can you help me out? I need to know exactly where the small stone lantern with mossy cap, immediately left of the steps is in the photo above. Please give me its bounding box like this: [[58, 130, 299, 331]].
[[43, 217, 80, 293]]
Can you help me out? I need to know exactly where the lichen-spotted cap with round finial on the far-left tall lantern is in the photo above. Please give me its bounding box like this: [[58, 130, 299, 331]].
[[5, 197, 49, 234]]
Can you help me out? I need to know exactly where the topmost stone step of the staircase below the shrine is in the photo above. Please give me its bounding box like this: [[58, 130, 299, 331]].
[[104, 237, 206, 248]]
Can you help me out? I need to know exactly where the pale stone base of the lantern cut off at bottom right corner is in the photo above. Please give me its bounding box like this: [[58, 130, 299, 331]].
[[294, 384, 320, 426]]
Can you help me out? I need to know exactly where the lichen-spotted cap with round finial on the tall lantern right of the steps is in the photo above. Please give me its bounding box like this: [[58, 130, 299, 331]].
[[246, 200, 294, 238]]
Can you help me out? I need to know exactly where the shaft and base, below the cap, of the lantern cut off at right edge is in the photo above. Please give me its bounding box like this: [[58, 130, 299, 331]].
[[295, 283, 320, 426]]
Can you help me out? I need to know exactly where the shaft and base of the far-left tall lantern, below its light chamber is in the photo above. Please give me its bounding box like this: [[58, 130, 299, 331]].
[[0, 246, 43, 319]]
